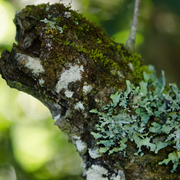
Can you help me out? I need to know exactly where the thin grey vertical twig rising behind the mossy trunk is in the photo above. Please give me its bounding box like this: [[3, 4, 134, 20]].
[[126, 0, 141, 51]]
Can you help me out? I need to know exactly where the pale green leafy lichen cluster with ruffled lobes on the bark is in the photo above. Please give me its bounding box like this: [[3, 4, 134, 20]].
[[91, 66, 180, 172]]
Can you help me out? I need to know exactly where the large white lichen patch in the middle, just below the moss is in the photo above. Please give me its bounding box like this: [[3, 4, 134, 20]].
[[55, 65, 84, 93]]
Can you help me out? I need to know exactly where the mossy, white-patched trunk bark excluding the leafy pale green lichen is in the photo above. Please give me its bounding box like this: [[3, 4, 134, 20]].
[[0, 4, 179, 180]]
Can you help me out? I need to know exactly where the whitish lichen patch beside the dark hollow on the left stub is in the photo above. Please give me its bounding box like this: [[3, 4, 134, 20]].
[[16, 53, 45, 75]]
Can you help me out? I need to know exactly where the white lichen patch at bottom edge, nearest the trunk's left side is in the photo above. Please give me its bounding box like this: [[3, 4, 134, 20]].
[[86, 165, 108, 180]]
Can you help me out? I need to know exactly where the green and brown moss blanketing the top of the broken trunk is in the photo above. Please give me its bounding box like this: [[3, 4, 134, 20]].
[[15, 3, 146, 89]]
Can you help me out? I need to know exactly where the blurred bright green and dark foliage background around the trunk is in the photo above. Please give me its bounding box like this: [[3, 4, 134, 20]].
[[0, 0, 180, 180]]
